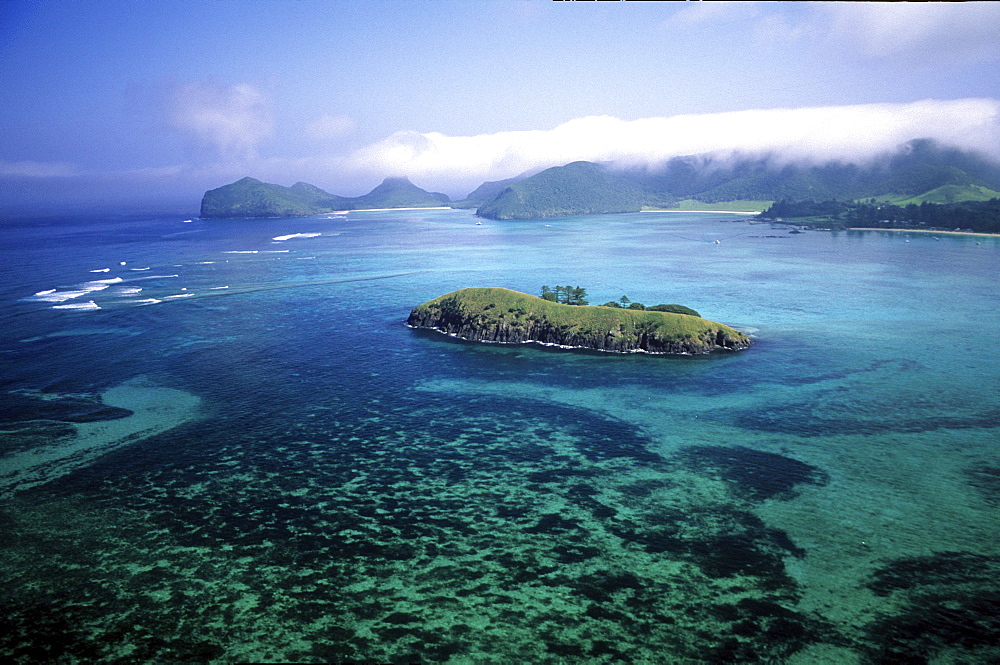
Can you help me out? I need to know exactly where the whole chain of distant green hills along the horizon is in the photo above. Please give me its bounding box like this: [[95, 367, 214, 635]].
[[201, 139, 1000, 225]]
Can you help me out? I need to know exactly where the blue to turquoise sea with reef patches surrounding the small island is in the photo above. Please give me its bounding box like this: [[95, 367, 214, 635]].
[[0, 210, 1000, 665]]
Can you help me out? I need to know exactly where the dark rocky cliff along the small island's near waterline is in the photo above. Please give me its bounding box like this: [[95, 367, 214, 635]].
[[407, 300, 752, 355]]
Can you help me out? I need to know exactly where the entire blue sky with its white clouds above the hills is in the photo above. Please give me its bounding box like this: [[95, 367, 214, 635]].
[[0, 0, 1000, 209]]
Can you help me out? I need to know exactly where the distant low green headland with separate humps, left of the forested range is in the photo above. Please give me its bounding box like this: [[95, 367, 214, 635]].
[[201, 178, 450, 218]]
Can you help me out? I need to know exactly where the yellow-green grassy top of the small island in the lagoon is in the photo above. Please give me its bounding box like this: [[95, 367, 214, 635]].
[[415, 287, 747, 340]]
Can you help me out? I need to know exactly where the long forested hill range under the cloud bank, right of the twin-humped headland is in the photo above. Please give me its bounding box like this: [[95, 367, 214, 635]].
[[470, 140, 1000, 219]]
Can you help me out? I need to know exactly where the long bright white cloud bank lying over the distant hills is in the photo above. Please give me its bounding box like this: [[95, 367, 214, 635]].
[[340, 99, 1000, 182]]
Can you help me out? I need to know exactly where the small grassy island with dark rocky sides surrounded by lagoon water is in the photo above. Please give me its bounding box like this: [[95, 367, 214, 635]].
[[406, 287, 753, 355]]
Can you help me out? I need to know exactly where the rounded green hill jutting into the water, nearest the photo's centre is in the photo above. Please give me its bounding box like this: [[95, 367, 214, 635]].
[[476, 162, 645, 219]]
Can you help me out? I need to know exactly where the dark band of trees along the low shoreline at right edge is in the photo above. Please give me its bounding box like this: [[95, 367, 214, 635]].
[[761, 199, 1000, 233]]
